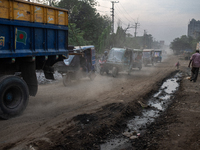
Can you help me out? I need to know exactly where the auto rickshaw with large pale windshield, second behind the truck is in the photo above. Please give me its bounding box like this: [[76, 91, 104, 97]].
[[106, 48, 133, 77]]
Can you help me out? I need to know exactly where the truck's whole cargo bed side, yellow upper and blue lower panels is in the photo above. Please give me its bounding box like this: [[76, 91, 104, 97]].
[[0, 0, 68, 58]]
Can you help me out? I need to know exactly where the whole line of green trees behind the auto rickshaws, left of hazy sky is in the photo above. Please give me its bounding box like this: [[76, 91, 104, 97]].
[[57, 0, 158, 53]]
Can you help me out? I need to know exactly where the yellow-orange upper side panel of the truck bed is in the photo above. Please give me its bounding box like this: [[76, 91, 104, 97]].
[[0, 0, 68, 26]]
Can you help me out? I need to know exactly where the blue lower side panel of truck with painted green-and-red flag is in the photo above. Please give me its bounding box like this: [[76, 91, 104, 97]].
[[0, 23, 68, 58]]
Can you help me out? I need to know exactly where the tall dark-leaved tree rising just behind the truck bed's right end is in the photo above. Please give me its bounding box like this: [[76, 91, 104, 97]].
[[58, 0, 110, 46]]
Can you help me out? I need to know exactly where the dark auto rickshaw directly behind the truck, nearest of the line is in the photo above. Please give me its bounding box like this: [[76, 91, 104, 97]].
[[55, 46, 96, 86]]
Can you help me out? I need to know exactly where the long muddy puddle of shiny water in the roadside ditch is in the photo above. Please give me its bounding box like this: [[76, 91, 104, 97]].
[[100, 73, 182, 150]]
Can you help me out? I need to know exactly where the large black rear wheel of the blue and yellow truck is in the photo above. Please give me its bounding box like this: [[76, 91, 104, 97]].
[[0, 75, 29, 119]]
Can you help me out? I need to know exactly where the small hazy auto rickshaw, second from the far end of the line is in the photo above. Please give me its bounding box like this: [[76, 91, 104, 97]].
[[143, 49, 155, 67]]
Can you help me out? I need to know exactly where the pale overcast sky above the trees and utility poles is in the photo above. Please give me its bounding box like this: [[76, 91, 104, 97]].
[[96, 0, 200, 45]]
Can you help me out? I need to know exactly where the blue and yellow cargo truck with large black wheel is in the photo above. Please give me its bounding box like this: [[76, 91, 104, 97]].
[[0, 0, 69, 119]]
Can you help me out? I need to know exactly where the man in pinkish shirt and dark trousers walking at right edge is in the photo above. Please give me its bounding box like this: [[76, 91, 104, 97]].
[[188, 50, 200, 82]]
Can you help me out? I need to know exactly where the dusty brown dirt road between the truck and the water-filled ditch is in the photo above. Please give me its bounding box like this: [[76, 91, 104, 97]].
[[0, 56, 181, 149]]
